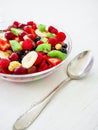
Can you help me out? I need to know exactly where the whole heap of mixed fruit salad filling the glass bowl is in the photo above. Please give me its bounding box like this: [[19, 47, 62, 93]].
[[0, 21, 68, 75]]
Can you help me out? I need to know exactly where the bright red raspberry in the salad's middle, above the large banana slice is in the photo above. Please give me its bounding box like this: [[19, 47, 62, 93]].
[[22, 39, 33, 50]]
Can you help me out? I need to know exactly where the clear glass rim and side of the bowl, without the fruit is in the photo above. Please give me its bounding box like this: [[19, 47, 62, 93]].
[[0, 22, 72, 82]]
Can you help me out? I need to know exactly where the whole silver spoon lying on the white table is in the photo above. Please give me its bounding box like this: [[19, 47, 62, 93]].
[[13, 50, 94, 130]]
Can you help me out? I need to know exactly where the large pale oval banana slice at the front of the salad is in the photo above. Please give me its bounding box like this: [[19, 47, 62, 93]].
[[22, 51, 38, 69]]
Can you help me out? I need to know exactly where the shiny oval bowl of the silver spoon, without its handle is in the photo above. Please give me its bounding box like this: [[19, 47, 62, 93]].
[[67, 51, 94, 79]]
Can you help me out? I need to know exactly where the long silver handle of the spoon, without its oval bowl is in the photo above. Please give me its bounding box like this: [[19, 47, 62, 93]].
[[13, 77, 70, 130]]
